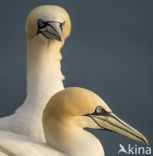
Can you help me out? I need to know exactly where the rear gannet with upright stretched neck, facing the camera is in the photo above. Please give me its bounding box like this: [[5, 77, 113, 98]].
[[0, 5, 71, 142]]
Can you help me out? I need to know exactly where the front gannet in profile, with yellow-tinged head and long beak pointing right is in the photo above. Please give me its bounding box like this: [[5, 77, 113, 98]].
[[0, 87, 148, 156]]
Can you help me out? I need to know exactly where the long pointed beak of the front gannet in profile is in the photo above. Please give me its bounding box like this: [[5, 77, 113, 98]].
[[89, 112, 148, 144]]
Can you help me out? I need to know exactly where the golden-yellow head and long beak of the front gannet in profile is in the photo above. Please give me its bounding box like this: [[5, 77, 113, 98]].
[[43, 87, 148, 144]]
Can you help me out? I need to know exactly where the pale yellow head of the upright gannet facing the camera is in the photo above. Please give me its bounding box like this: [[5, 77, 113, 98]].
[[26, 5, 71, 41]]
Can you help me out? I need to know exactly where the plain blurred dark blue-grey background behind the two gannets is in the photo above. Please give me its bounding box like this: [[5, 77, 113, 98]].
[[0, 0, 153, 156]]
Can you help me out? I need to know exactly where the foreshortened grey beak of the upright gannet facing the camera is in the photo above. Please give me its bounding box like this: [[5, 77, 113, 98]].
[[37, 19, 65, 41]]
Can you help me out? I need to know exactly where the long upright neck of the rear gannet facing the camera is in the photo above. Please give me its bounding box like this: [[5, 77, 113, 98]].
[[18, 37, 64, 113]]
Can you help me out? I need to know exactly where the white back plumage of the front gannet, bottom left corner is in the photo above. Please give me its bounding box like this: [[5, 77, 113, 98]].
[[0, 130, 62, 156]]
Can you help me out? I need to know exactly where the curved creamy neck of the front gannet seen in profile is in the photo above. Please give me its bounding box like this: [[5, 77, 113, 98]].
[[44, 118, 104, 156]]
